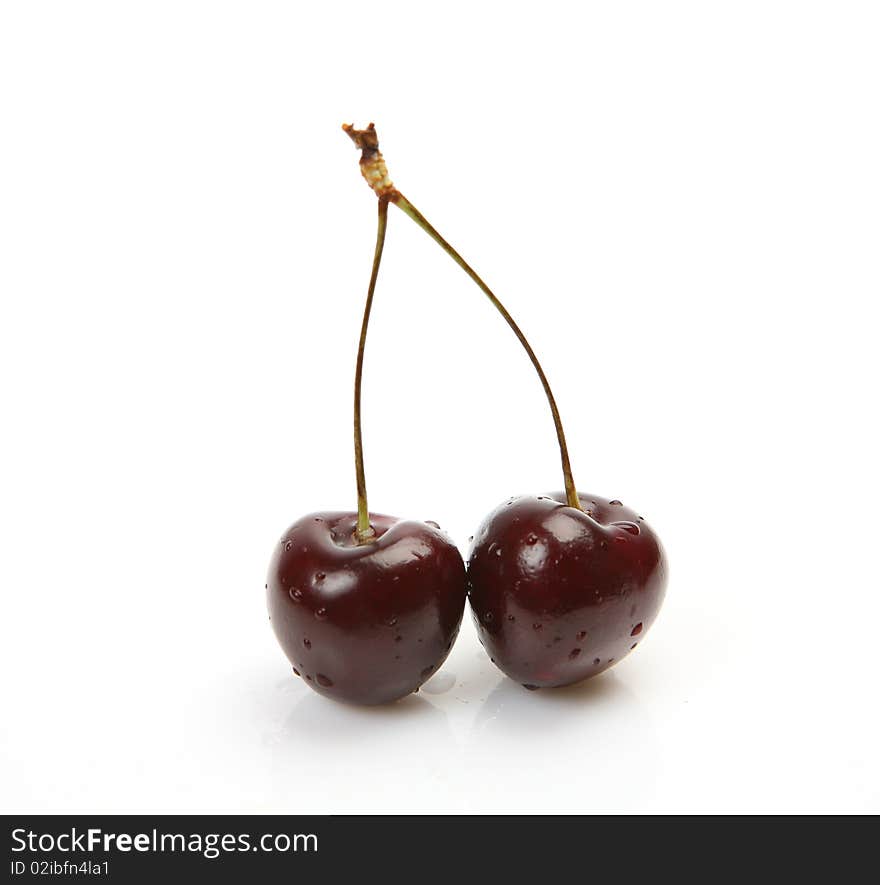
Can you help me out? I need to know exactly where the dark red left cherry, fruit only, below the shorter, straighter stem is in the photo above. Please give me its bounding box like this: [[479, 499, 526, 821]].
[[266, 512, 467, 704]]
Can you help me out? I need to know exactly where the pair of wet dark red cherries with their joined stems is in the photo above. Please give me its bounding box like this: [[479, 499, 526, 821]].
[[266, 124, 667, 704]]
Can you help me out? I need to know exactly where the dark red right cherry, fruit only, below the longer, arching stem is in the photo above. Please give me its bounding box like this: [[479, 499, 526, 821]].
[[468, 493, 667, 688]]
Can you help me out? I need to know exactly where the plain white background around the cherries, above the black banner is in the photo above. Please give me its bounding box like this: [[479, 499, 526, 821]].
[[0, 0, 880, 812]]
